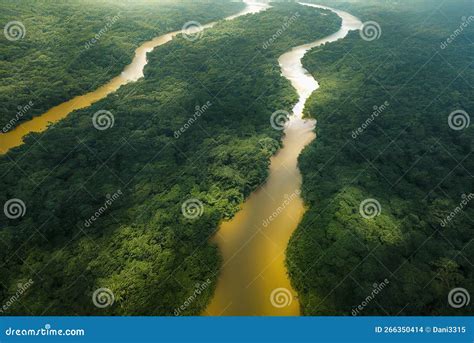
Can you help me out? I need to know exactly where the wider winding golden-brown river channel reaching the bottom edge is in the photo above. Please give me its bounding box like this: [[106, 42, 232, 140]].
[[203, 3, 362, 316]]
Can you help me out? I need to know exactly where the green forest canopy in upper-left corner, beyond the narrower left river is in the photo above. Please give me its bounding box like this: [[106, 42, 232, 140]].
[[0, 0, 244, 130]]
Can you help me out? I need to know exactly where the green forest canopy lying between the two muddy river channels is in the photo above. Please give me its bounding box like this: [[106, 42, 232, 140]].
[[0, 0, 340, 315]]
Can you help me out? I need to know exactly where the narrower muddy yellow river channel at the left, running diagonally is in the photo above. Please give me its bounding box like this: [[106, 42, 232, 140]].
[[0, 0, 269, 154]]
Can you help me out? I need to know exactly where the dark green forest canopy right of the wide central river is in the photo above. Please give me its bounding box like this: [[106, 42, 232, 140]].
[[287, 0, 474, 315]]
